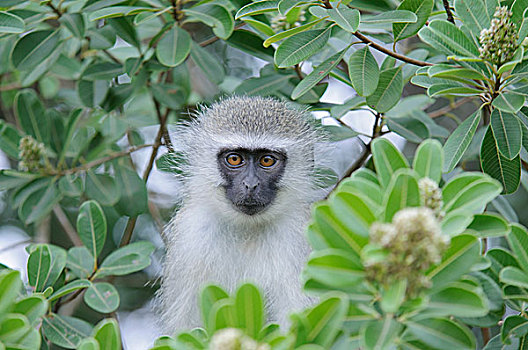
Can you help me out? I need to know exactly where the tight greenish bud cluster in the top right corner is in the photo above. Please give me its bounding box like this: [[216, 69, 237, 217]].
[[479, 6, 519, 66]]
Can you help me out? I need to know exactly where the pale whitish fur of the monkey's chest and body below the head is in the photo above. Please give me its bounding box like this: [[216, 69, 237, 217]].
[[160, 205, 311, 334]]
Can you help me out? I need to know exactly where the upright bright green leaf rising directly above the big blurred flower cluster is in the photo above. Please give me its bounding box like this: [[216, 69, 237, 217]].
[[383, 169, 421, 222]]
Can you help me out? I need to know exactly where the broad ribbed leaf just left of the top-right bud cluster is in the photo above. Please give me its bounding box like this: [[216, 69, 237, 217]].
[[418, 20, 479, 57]]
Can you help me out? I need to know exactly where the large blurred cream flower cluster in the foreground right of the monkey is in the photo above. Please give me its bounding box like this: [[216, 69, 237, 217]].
[[365, 207, 449, 297]]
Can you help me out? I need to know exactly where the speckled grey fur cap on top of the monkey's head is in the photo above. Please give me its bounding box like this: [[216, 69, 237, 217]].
[[199, 96, 314, 139]]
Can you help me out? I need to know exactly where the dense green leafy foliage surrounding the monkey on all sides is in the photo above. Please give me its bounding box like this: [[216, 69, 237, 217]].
[[0, 0, 528, 350]]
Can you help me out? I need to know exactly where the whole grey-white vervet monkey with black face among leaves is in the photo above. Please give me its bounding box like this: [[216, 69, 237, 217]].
[[159, 97, 321, 333]]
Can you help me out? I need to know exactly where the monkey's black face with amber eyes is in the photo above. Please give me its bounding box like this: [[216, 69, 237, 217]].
[[218, 148, 287, 215]]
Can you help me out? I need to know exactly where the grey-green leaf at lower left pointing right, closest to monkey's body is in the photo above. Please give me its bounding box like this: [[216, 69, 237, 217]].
[[96, 241, 155, 277]]
